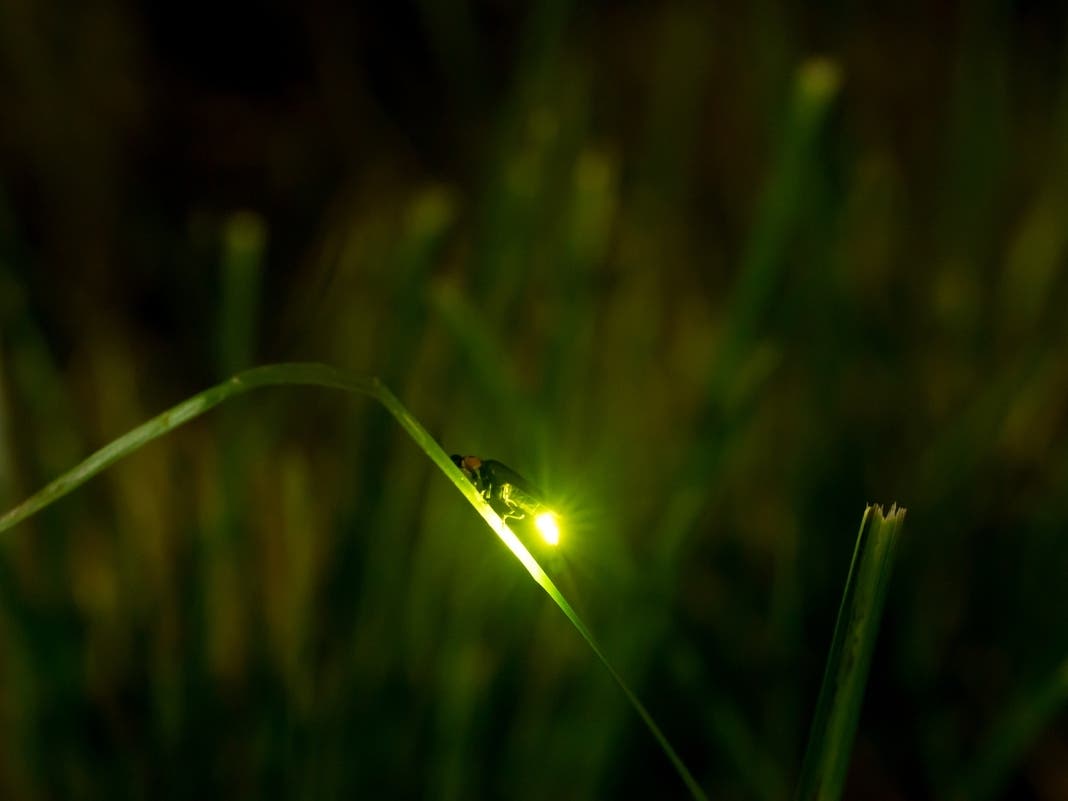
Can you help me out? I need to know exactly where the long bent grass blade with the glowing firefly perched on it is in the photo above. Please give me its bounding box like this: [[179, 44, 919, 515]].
[[0, 363, 706, 801]]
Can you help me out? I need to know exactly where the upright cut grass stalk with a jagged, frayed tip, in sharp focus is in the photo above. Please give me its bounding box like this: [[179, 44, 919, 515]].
[[796, 506, 905, 801]]
